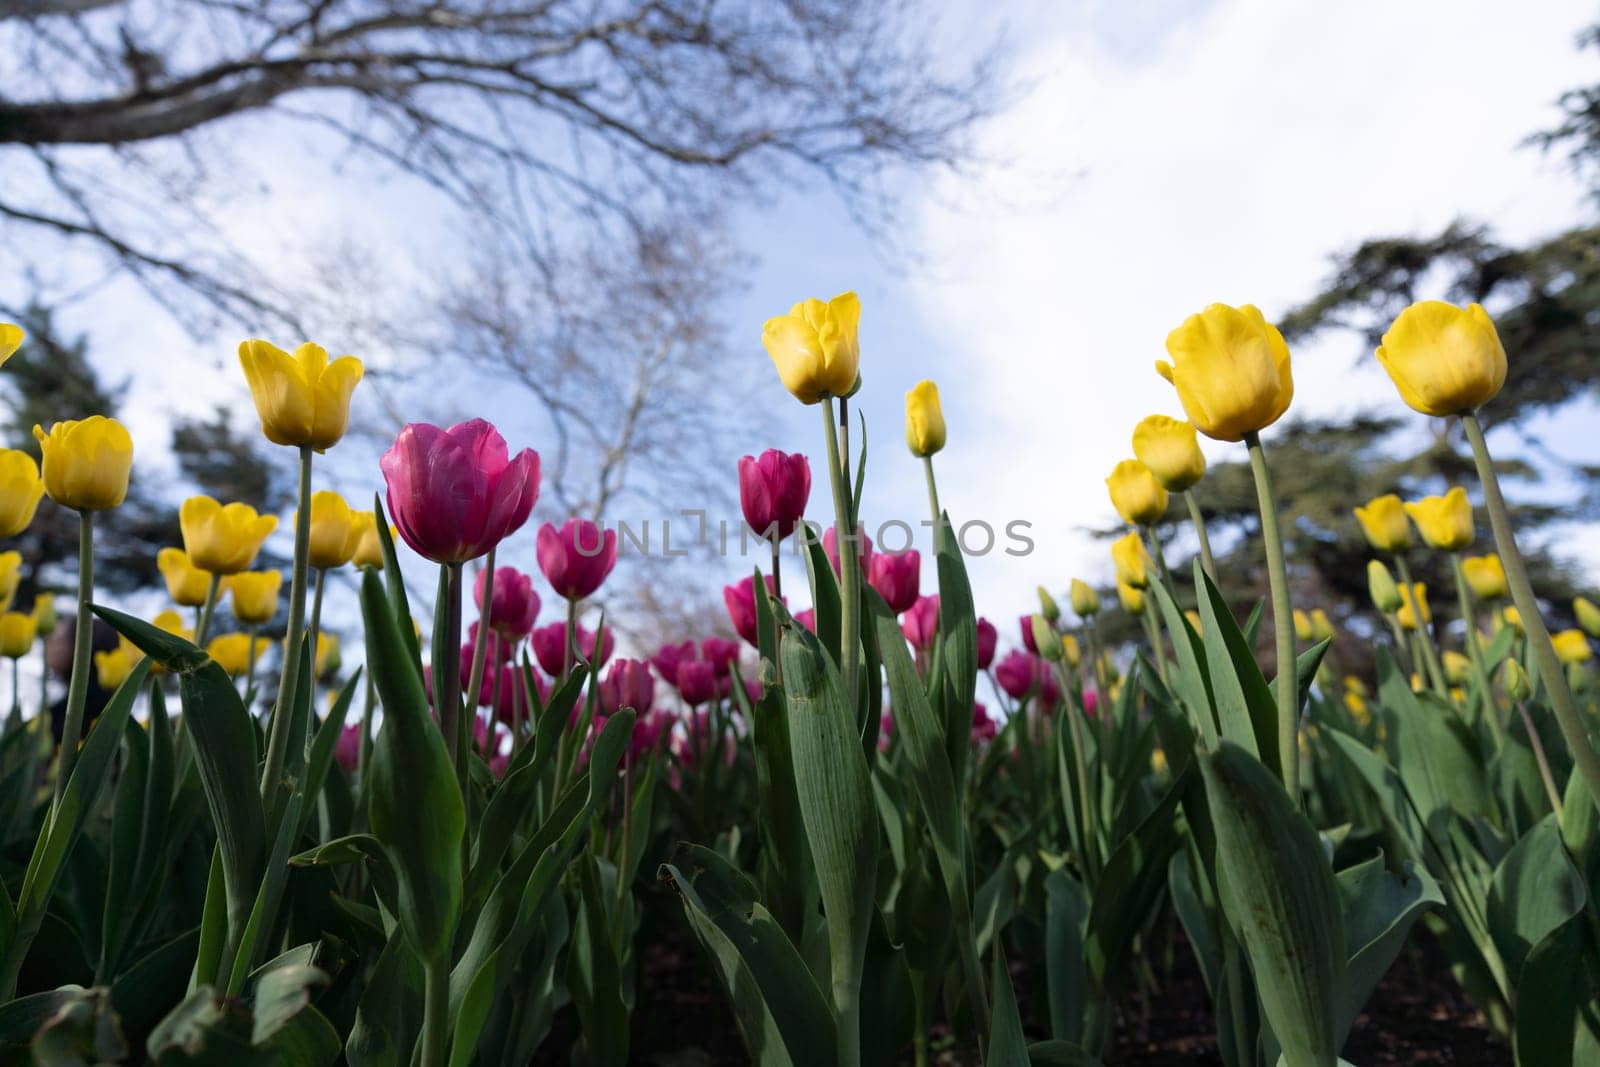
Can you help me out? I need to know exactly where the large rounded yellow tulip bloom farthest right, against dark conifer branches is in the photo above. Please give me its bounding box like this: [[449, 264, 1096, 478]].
[[1378, 301, 1506, 416]]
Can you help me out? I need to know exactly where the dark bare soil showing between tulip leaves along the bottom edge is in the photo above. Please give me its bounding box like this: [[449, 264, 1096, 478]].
[[534, 928, 1512, 1067]]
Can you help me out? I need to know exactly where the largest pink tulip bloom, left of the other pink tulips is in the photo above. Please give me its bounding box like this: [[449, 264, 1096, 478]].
[[379, 419, 539, 563]]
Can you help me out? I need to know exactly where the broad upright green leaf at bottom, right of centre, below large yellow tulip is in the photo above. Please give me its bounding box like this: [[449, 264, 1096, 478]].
[[1200, 741, 1346, 1067]]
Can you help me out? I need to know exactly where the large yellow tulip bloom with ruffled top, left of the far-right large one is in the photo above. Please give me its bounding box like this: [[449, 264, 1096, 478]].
[[1155, 304, 1294, 442]]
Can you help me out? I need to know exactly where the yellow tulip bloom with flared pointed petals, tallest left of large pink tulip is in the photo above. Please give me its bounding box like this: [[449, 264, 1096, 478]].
[[238, 341, 366, 451]]
